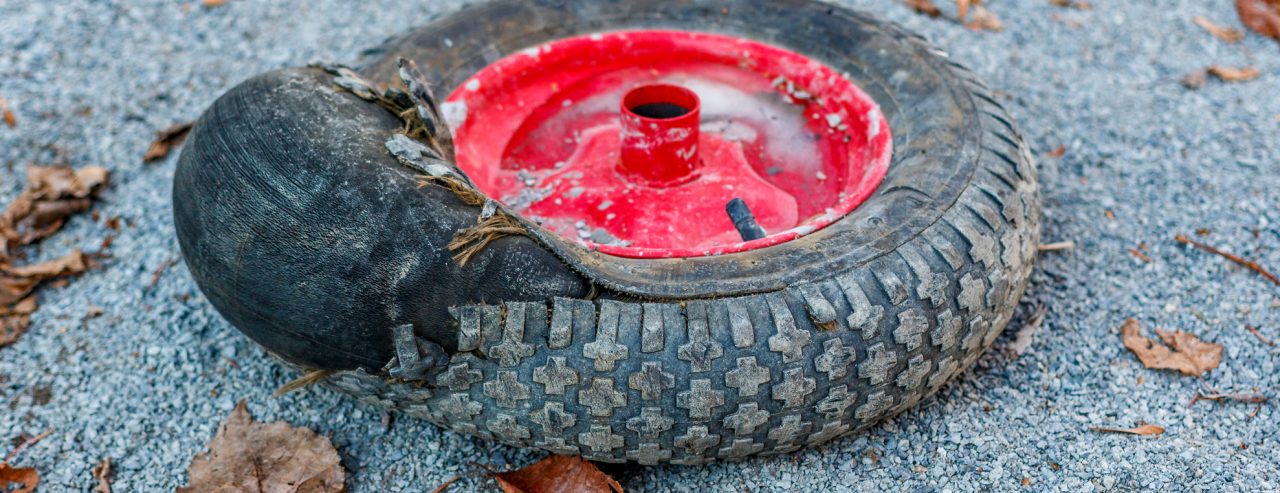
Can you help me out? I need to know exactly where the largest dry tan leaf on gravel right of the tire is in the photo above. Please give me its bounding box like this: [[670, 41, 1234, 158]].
[[1120, 319, 1222, 376]]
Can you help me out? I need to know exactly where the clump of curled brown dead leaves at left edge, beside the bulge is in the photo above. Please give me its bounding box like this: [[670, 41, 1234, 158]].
[[0, 165, 108, 347]]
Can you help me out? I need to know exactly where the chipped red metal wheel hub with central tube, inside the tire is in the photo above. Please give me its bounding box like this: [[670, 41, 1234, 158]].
[[442, 31, 892, 257]]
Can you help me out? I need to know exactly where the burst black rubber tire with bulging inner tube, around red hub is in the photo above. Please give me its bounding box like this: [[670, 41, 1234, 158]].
[[174, 0, 1041, 464]]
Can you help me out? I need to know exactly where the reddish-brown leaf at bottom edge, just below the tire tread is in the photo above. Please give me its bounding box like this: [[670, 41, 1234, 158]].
[[493, 456, 622, 493]]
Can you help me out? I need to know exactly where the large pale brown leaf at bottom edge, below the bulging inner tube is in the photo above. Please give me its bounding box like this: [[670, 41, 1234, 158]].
[[178, 401, 346, 493]]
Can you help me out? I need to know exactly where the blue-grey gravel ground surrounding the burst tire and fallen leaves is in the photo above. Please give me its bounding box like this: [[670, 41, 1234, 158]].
[[0, 0, 1280, 492]]
